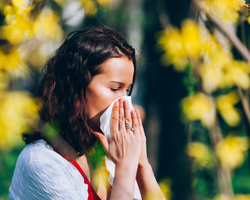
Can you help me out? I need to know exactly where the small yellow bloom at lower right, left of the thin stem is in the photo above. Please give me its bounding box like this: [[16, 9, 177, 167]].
[[187, 142, 215, 168]]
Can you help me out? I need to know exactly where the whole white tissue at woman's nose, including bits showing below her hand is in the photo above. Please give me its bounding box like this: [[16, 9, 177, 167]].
[[100, 96, 142, 200]]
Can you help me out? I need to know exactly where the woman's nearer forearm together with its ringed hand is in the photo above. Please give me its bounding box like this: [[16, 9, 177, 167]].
[[95, 99, 141, 200]]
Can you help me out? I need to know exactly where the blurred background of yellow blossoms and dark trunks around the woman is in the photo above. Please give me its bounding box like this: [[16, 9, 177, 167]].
[[0, 0, 250, 200]]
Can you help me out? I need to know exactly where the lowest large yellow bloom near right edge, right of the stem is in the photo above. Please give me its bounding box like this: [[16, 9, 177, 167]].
[[215, 135, 249, 170]]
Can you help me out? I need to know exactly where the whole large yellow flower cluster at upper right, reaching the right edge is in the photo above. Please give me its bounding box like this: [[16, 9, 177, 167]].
[[158, 20, 250, 93]]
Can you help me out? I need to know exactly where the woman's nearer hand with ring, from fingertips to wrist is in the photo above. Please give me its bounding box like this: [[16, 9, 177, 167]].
[[95, 99, 142, 167]]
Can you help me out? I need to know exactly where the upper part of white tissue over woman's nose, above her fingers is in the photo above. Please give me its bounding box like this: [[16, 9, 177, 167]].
[[100, 96, 134, 141]]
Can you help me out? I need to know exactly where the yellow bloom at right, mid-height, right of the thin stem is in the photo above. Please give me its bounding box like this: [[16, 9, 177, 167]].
[[216, 91, 241, 126]]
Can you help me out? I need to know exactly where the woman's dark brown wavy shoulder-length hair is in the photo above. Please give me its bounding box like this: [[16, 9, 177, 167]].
[[23, 27, 136, 155]]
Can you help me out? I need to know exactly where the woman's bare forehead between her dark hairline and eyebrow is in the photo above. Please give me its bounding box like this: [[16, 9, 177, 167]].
[[101, 57, 134, 84]]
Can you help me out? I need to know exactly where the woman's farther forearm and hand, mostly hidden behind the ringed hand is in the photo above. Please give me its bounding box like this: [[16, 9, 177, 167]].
[[136, 111, 166, 200]]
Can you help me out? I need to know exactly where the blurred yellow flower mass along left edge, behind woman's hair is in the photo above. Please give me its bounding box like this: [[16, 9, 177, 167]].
[[0, 0, 111, 149]]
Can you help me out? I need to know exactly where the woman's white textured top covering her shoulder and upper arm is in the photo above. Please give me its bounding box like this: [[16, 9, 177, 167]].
[[9, 140, 88, 200]]
